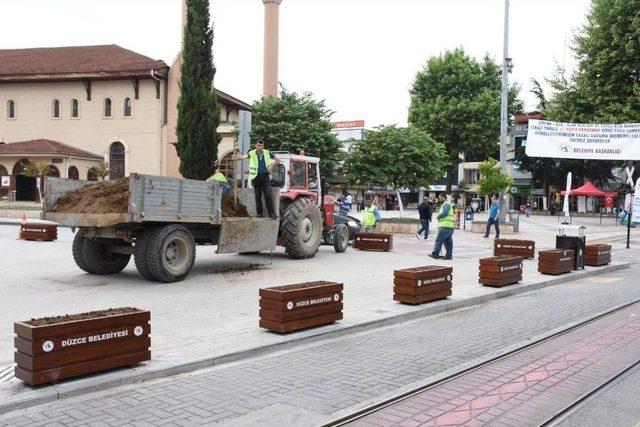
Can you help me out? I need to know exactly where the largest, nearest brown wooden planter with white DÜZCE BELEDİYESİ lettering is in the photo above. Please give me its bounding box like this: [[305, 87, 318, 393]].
[[13, 308, 151, 385]]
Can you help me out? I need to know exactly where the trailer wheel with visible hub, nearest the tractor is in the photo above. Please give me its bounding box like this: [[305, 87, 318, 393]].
[[146, 224, 196, 283]]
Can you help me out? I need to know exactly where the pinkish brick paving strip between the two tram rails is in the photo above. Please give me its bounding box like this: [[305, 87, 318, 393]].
[[349, 304, 640, 427]]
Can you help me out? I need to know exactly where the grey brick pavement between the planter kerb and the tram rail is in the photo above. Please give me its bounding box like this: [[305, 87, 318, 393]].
[[0, 267, 640, 426]]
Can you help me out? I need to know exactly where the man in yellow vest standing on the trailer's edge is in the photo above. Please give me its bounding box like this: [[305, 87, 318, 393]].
[[232, 139, 280, 218]]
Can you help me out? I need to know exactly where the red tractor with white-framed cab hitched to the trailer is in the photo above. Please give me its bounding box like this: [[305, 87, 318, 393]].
[[272, 152, 349, 258]]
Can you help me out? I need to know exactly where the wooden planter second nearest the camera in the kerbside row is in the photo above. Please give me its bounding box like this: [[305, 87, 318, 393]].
[[260, 282, 343, 333]]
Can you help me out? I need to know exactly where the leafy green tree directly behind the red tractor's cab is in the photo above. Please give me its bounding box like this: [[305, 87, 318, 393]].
[[251, 90, 340, 176]]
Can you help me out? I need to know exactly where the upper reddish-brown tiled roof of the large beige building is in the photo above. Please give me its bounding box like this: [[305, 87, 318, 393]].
[[0, 44, 168, 81]]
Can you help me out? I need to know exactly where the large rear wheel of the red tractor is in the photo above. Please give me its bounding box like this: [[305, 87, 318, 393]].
[[280, 197, 322, 259]]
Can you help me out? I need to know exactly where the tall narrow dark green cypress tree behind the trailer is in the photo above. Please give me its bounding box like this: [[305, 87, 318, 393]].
[[175, 0, 220, 180]]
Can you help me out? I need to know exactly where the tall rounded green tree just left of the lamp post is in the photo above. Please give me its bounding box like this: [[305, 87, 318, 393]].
[[409, 48, 522, 191]]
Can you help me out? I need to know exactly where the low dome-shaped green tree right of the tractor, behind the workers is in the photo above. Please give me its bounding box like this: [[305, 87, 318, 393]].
[[345, 125, 447, 189]]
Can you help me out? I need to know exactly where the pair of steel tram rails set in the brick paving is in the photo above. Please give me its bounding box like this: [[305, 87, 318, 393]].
[[323, 299, 640, 427]]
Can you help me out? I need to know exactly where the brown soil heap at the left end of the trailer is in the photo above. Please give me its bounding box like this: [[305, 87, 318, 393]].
[[51, 178, 129, 214]]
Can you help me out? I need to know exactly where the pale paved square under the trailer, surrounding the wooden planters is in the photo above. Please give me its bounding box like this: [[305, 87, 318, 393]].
[[0, 218, 632, 412]]
